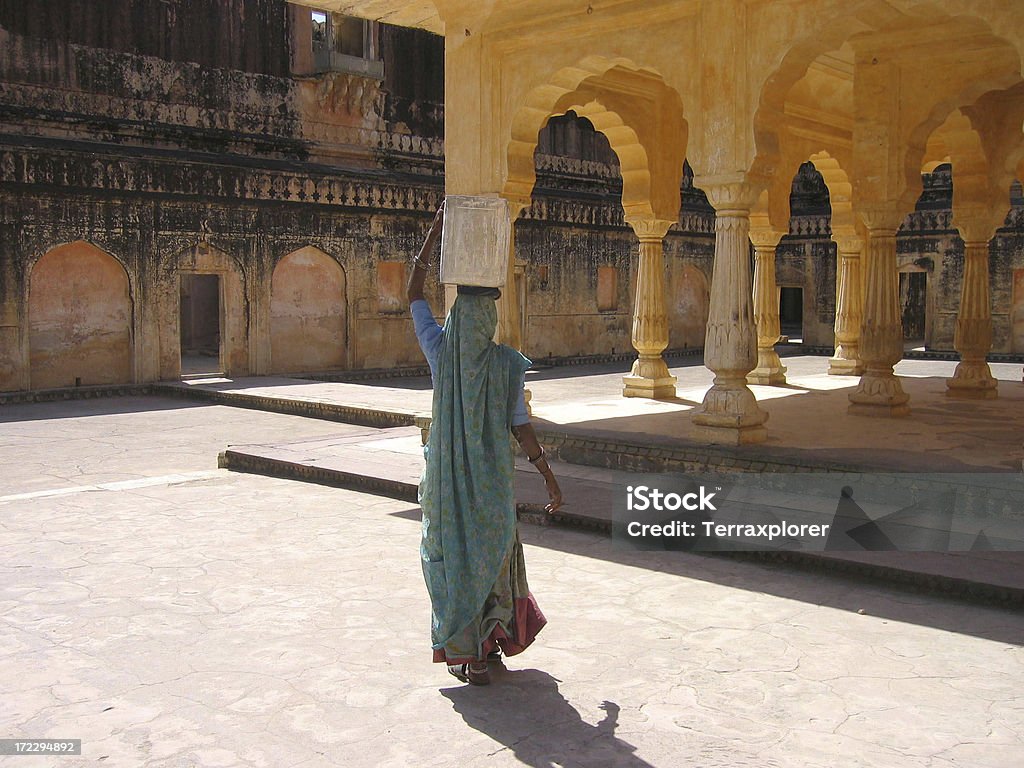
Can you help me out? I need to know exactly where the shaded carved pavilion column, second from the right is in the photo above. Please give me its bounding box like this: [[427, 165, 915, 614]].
[[849, 209, 910, 416]]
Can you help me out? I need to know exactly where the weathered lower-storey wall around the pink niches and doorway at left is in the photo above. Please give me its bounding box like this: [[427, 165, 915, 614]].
[[0, 189, 456, 390]]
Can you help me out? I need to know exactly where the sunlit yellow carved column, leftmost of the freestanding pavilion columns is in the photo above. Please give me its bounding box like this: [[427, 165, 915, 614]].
[[623, 219, 676, 399]]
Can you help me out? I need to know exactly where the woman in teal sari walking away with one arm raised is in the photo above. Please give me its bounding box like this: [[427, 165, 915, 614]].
[[408, 206, 562, 685]]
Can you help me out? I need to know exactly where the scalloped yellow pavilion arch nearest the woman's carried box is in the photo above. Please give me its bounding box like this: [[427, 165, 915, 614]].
[[502, 56, 686, 220]]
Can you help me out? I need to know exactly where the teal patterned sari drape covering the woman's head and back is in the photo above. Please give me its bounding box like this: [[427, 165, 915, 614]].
[[419, 295, 529, 651]]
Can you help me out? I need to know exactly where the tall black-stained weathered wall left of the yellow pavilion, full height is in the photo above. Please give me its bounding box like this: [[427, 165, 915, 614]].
[[0, 0, 452, 390]]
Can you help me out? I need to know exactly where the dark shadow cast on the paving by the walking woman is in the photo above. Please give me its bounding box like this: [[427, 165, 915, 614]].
[[441, 664, 651, 768]]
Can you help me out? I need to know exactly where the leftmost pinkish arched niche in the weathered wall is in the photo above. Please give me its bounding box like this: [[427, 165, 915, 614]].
[[28, 241, 133, 389]]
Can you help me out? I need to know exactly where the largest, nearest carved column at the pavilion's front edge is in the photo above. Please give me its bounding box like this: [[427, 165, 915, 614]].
[[693, 182, 768, 444]]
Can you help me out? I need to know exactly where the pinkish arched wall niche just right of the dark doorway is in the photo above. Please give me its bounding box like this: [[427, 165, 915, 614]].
[[270, 246, 347, 374]]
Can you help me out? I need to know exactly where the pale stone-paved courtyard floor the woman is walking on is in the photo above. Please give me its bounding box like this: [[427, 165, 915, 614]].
[[0, 397, 1024, 768]]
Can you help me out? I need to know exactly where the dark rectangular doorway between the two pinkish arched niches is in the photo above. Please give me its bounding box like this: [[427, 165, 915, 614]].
[[181, 274, 224, 376]]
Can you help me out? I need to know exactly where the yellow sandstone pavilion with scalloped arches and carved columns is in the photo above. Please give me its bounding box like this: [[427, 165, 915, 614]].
[[304, 0, 1024, 443]]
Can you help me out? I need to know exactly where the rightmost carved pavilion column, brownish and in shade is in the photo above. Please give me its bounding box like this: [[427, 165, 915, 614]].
[[946, 217, 997, 399]]
